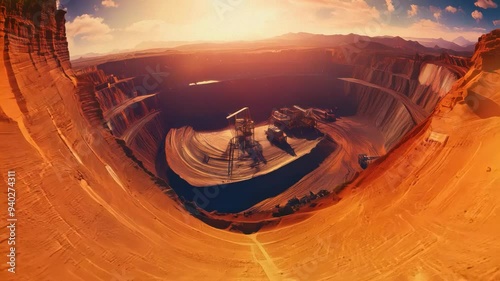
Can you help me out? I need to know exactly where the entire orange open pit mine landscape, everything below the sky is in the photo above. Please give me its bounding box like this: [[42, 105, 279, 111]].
[[0, 0, 500, 280]]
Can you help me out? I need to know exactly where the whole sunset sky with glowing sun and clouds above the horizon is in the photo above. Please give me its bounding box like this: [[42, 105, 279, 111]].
[[59, 0, 500, 57]]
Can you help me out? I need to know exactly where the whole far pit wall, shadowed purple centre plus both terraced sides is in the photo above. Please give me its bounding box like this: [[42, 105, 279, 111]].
[[91, 49, 467, 180]]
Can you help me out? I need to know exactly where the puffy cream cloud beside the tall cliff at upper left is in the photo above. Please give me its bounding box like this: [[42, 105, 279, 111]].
[[66, 14, 113, 42]]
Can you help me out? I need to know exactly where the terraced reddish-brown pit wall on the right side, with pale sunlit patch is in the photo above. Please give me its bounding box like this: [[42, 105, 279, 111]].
[[345, 55, 464, 150]]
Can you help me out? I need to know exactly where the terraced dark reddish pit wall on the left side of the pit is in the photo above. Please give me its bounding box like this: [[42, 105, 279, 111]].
[[77, 67, 168, 173]]
